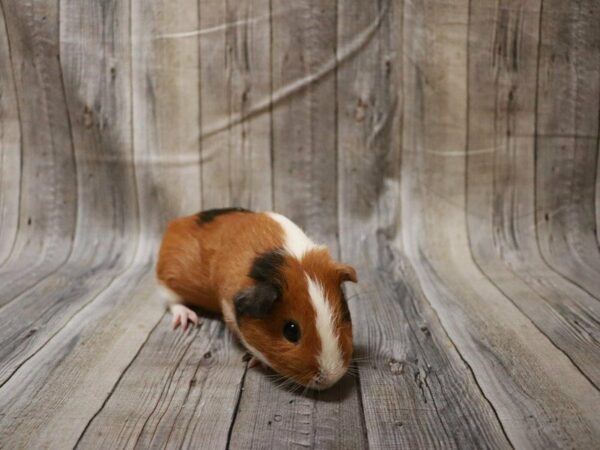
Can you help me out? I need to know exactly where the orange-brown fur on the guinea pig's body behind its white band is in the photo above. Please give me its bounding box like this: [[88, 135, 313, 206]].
[[157, 212, 283, 313]]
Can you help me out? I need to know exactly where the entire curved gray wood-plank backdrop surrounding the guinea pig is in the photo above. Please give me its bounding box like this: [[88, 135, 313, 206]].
[[0, 0, 600, 449]]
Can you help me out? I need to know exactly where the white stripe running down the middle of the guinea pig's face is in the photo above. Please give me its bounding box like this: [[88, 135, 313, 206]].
[[306, 275, 346, 387]]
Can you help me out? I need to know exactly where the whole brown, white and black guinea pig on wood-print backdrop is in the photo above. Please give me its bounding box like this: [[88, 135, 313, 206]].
[[157, 208, 356, 389]]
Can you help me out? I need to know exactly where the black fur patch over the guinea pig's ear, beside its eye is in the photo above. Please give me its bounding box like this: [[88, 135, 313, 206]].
[[233, 250, 284, 320]]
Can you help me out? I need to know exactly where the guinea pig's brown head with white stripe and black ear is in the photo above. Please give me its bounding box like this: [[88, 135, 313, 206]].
[[234, 247, 356, 389]]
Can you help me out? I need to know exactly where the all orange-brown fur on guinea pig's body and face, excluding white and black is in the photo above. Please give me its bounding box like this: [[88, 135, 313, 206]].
[[157, 212, 356, 384]]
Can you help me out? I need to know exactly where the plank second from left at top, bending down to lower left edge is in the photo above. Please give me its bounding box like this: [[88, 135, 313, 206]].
[[0, 2, 138, 383]]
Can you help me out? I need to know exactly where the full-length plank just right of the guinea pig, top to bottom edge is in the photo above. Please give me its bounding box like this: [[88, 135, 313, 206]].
[[338, 2, 509, 448]]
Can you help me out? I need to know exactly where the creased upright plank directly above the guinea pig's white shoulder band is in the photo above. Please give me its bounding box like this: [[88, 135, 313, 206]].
[[271, 0, 338, 254]]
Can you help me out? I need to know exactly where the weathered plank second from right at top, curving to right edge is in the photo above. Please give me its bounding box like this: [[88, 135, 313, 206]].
[[467, 1, 600, 386]]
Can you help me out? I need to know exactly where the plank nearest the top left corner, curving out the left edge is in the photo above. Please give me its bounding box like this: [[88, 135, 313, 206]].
[[0, 1, 77, 305]]
